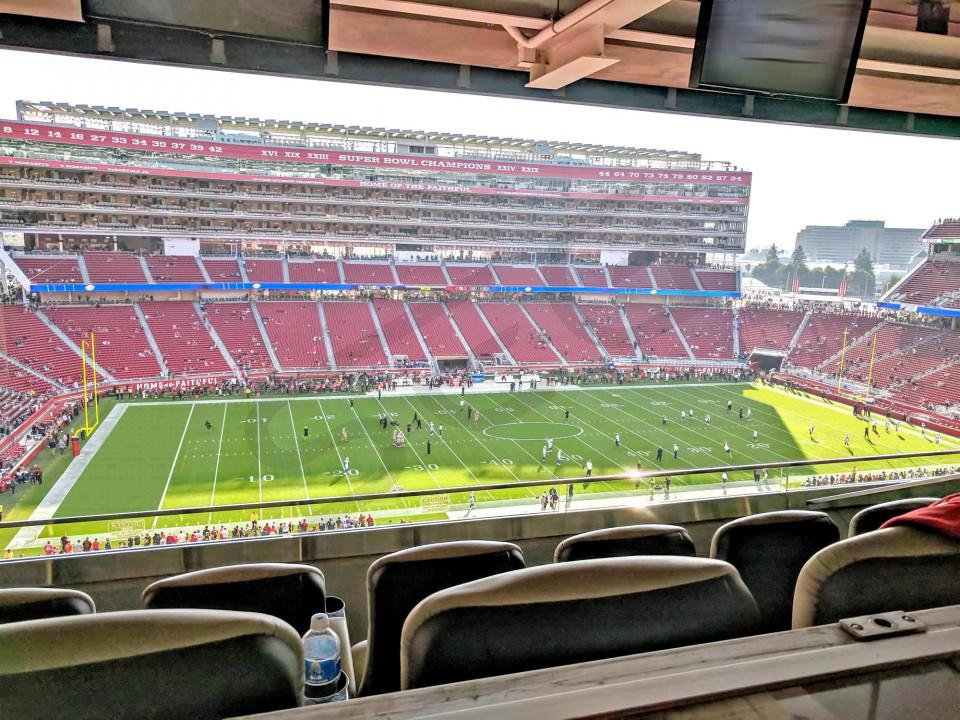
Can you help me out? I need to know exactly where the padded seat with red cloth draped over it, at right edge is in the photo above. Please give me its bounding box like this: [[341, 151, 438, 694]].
[[793, 527, 960, 628]]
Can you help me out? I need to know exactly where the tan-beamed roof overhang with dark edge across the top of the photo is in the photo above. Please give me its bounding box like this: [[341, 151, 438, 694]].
[[0, 0, 960, 137]]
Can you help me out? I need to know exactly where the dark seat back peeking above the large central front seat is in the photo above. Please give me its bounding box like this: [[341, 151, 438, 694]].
[[553, 524, 697, 562]]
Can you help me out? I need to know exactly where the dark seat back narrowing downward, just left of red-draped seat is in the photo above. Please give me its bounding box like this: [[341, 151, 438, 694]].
[[710, 510, 840, 632]]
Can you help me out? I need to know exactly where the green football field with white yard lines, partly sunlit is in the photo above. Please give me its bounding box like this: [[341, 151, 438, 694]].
[[3, 383, 957, 548]]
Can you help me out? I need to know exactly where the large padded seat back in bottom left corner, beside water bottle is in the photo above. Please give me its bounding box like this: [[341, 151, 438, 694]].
[[0, 610, 303, 720]]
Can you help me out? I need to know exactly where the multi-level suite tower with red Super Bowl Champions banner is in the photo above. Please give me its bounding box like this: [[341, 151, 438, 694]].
[[0, 101, 751, 265]]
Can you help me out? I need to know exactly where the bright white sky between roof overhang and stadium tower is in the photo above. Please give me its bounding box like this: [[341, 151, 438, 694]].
[[0, 50, 960, 248]]
